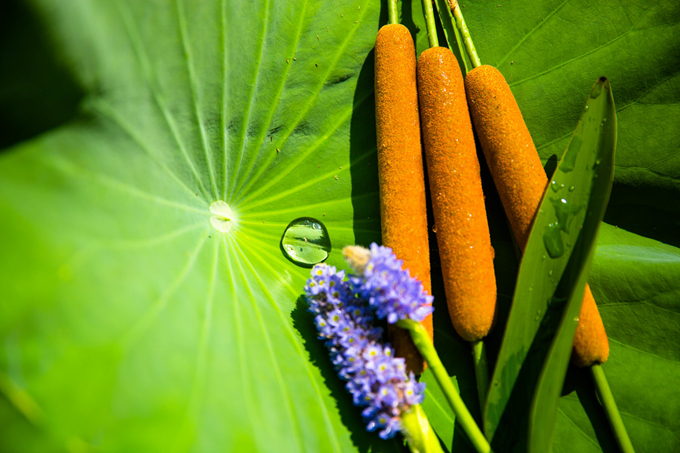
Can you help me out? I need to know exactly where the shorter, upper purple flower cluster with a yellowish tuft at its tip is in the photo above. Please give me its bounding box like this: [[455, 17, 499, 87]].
[[343, 243, 434, 324]]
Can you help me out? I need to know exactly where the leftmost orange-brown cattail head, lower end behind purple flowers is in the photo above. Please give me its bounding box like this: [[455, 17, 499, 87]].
[[375, 24, 432, 373]]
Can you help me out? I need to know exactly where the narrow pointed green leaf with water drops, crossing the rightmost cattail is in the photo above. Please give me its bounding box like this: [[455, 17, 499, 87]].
[[484, 78, 616, 444]]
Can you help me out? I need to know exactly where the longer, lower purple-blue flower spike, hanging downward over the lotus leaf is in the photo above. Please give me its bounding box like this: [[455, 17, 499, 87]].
[[305, 264, 425, 439]]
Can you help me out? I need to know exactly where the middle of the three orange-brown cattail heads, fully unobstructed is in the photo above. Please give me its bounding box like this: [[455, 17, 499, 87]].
[[418, 47, 496, 341]]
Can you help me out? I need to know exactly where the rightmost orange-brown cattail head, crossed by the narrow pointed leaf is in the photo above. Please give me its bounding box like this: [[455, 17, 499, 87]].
[[465, 65, 609, 366]]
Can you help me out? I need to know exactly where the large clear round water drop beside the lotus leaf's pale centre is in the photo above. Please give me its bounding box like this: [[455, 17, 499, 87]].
[[281, 217, 331, 267]]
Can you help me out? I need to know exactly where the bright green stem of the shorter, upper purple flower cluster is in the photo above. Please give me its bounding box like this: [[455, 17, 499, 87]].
[[397, 319, 491, 453]]
